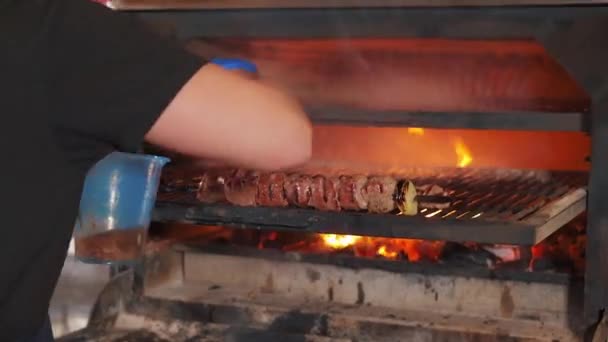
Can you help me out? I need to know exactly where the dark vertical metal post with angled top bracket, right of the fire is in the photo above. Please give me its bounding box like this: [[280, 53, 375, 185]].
[[541, 14, 608, 325]]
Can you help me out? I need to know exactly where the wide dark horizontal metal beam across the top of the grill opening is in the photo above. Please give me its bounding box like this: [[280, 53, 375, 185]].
[[135, 6, 608, 39]]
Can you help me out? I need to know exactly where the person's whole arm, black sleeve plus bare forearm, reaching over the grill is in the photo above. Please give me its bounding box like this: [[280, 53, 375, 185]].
[[46, 0, 312, 170]]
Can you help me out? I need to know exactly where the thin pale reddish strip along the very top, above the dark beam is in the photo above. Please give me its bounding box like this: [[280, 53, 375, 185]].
[[111, 0, 608, 10]]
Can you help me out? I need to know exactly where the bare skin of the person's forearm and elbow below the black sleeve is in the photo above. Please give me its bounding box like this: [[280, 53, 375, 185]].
[[146, 64, 312, 170]]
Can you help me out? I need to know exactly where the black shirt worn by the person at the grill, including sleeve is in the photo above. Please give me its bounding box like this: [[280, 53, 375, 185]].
[[0, 0, 202, 341]]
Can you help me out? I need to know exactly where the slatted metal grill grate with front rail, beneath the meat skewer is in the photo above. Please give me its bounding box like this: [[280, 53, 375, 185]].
[[155, 169, 587, 244]]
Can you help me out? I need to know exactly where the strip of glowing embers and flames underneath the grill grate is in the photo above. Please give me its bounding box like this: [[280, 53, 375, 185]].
[[148, 215, 586, 275]]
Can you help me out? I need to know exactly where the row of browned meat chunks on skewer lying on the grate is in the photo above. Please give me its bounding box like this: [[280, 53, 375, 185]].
[[198, 170, 432, 215]]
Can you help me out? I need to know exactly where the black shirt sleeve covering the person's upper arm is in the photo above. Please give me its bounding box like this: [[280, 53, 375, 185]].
[[45, 0, 204, 151]]
